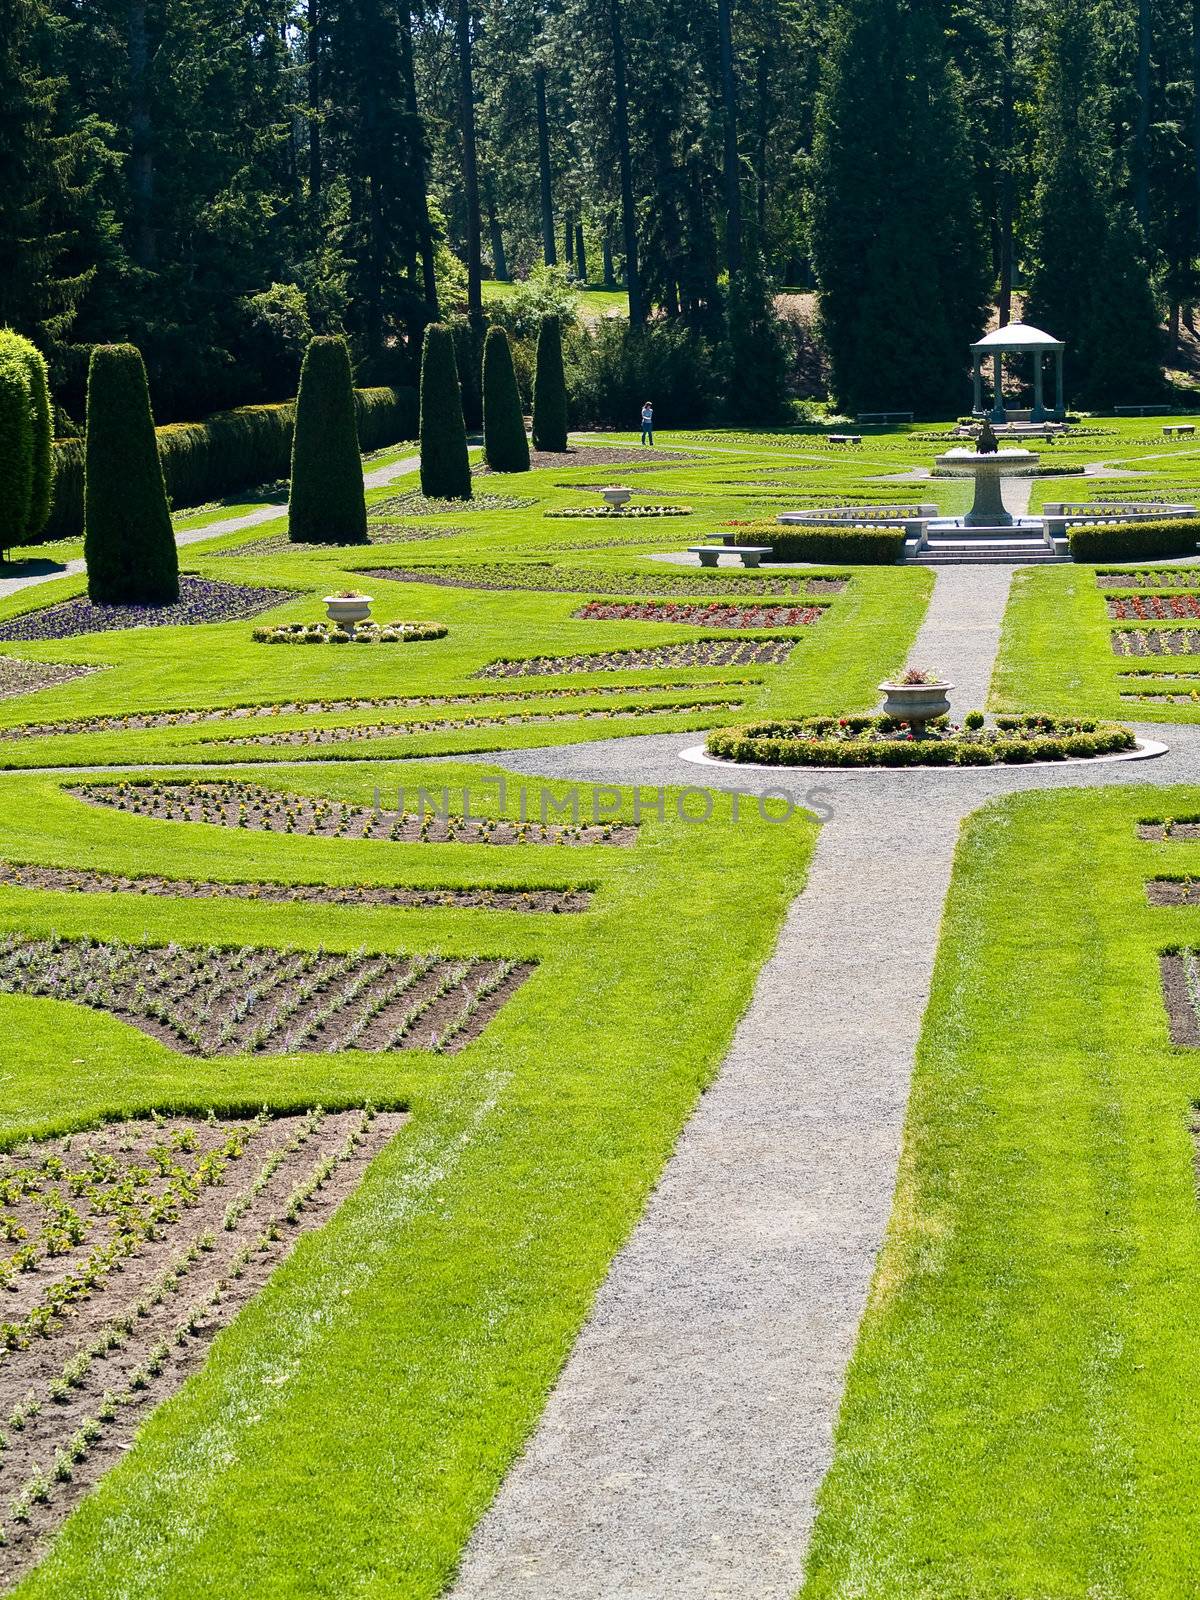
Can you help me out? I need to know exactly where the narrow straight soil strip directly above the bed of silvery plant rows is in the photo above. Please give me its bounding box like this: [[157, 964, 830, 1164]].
[[0, 861, 592, 912]]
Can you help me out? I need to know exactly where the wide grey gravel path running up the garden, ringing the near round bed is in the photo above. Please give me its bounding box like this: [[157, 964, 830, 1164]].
[[451, 565, 1200, 1600]]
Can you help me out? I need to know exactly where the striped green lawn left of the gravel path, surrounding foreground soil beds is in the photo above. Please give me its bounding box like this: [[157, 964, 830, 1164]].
[[0, 763, 814, 1600]]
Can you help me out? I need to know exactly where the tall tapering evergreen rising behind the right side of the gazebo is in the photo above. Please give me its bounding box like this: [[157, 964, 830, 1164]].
[[1026, 0, 1162, 406]]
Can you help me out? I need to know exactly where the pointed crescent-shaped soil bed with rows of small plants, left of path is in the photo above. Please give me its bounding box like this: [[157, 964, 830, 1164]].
[[69, 779, 637, 845]]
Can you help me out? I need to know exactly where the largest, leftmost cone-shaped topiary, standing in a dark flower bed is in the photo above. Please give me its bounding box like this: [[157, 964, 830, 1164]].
[[83, 344, 179, 605]]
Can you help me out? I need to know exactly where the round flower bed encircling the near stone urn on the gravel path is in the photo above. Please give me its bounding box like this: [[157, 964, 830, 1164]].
[[707, 712, 1138, 766]]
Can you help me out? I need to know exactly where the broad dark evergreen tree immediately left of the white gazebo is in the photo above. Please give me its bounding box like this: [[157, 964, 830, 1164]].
[[811, 0, 986, 413]]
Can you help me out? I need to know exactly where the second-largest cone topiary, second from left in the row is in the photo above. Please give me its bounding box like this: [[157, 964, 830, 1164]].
[[288, 336, 366, 544]]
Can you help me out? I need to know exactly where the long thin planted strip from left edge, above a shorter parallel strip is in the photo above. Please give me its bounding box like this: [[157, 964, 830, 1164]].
[[0, 678, 748, 739]]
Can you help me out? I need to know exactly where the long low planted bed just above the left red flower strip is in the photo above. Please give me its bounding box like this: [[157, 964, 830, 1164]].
[[360, 562, 850, 598]]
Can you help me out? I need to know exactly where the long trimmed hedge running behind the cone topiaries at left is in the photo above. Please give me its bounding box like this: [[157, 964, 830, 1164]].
[[45, 389, 418, 539]]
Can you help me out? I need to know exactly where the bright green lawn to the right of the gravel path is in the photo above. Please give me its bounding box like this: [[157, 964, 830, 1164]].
[[803, 789, 1200, 1600]]
